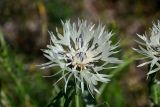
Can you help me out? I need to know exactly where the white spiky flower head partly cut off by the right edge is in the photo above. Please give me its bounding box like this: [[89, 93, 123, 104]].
[[134, 21, 160, 76]]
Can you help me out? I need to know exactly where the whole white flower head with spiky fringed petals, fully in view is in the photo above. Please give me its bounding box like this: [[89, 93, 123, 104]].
[[40, 20, 122, 94]]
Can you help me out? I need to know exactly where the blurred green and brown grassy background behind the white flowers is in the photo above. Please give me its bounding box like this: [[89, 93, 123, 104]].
[[0, 0, 160, 107]]
